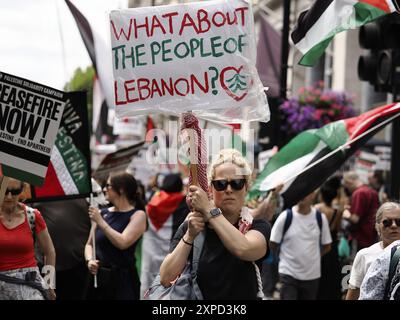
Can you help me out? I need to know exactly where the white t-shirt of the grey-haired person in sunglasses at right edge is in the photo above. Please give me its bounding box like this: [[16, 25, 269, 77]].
[[349, 242, 383, 288]]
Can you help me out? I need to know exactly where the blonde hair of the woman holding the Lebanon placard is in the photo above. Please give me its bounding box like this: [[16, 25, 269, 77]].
[[208, 149, 252, 186]]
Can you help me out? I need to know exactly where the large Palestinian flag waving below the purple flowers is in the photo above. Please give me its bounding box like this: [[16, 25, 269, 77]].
[[248, 103, 400, 207]]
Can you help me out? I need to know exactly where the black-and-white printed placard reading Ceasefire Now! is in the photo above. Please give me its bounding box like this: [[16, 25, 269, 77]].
[[0, 72, 66, 185]]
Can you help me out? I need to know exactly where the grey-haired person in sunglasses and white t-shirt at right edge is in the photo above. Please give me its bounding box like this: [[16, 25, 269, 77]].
[[346, 202, 400, 300]]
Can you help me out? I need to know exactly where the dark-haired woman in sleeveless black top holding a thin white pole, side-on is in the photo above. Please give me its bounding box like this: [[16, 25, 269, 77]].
[[85, 172, 146, 300]]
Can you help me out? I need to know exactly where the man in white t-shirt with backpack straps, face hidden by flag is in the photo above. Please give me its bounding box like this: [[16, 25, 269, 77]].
[[270, 192, 332, 300]]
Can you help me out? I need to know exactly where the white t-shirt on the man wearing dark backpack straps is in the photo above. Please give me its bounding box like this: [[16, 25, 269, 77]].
[[271, 207, 332, 280]]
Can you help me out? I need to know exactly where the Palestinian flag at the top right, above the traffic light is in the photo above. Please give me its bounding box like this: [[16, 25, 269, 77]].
[[292, 0, 400, 66]]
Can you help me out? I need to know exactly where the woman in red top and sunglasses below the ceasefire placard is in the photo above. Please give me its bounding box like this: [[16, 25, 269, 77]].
[[0, 178, 56, 300]]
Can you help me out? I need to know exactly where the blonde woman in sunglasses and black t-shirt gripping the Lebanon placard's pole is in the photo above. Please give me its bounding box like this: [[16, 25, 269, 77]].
[[160, 149, 270, 300]]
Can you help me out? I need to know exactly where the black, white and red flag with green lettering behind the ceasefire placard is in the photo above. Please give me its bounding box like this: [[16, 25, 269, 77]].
[[29, 92, 92, 202]]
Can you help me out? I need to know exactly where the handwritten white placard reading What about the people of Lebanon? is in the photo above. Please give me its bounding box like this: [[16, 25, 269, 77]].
[[110, 0, 269, 121]]
